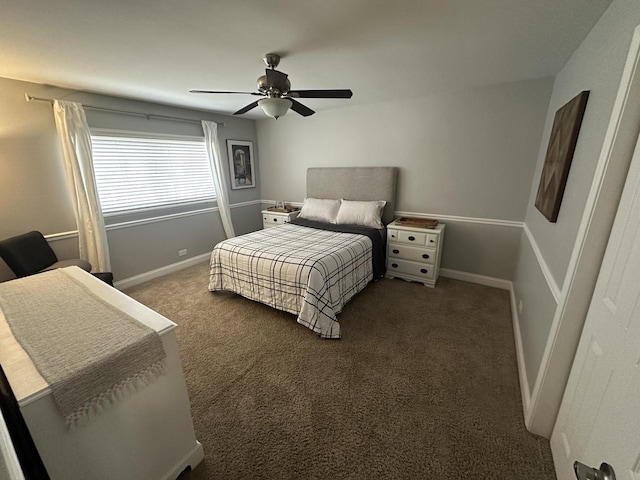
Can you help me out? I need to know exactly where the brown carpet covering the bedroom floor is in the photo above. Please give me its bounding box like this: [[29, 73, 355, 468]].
[[127, 264, 555, 480]]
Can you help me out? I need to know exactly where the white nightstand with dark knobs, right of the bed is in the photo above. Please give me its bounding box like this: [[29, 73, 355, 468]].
[[386, 220, 445, 288]]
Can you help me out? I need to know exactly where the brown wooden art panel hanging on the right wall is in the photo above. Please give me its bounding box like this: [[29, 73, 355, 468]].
[[535, 91, 589, 223]]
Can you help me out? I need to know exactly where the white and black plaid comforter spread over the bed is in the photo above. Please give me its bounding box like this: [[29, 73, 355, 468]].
[[209, 224, 373, 338]]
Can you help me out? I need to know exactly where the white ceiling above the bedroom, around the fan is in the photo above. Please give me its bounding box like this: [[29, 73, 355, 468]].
[[0, 0, 611, 118]]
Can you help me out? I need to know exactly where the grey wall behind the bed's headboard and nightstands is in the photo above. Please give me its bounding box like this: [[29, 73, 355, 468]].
[[257, 78, 553, 280]]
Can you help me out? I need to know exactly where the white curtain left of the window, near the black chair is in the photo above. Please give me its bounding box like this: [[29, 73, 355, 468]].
[[53, 100, 111, 272]]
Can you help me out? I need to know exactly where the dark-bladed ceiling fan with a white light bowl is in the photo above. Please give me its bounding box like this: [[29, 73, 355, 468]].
[[189, 53, 353, 120]]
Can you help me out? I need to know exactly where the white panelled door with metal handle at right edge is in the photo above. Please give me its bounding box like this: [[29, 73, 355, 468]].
[[551, 129, 640, 480]]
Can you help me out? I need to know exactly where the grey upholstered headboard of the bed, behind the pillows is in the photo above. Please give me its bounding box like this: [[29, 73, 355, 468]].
[[307, 167, 398, 225]]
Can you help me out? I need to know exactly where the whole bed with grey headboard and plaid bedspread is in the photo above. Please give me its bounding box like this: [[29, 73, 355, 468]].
[[209, 167, 397, 338]]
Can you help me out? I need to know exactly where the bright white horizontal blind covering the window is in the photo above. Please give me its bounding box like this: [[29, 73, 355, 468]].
[[91, 133, 215, 214]]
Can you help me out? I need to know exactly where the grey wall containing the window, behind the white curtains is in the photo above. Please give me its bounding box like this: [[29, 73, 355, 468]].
[[0, 78, 261, 281]]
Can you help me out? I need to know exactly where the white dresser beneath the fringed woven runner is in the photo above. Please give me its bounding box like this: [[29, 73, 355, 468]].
[[0, 267, 203, 480]]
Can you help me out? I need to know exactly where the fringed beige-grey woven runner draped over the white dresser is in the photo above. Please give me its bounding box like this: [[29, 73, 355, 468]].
[[0, 270, 166, 426]]
